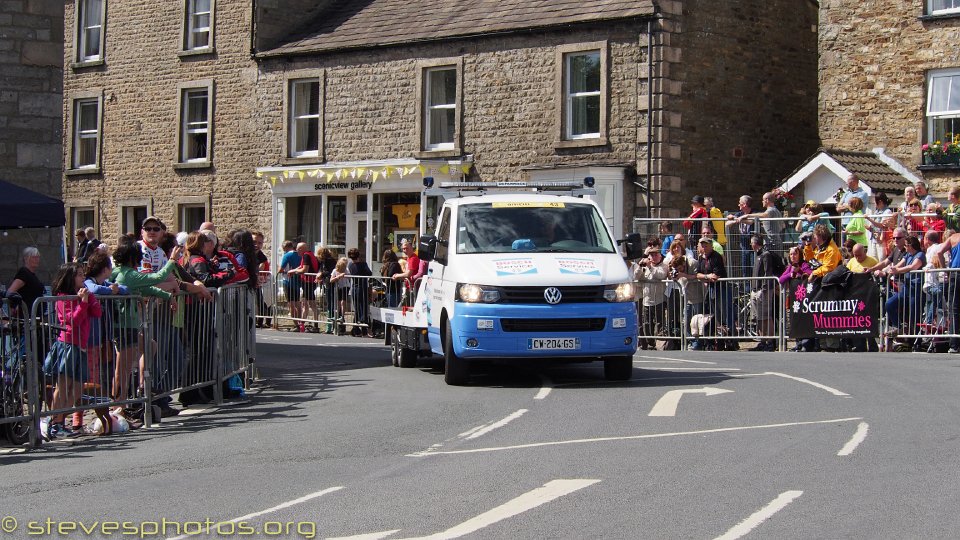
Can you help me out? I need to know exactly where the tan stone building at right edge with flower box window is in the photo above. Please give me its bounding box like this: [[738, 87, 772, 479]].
[[819, 0, 960, 198]]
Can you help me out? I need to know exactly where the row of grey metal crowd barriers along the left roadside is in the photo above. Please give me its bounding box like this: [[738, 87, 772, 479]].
[[0, 285, 258, 446]]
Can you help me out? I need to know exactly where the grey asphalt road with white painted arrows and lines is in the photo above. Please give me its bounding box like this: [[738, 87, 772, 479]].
[[0, 332, 960, 540]]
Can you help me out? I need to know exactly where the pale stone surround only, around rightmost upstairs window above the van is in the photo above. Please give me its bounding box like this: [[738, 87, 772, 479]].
[[554, 41, 610, 149]]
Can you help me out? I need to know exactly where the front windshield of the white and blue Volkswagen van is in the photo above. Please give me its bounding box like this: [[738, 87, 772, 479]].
[[457, 202, 616, 253]]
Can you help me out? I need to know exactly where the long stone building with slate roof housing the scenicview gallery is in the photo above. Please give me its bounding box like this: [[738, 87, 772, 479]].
[[64, 0, 818, 266]]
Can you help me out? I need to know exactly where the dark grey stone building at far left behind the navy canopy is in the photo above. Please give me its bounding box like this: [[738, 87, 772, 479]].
[[0, 0, 64, 285]]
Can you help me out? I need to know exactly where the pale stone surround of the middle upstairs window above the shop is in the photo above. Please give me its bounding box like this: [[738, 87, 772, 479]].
[[416, 57, 464, 158]]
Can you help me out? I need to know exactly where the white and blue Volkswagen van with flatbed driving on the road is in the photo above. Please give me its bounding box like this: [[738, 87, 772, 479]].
[[381, 182, 642, 385]]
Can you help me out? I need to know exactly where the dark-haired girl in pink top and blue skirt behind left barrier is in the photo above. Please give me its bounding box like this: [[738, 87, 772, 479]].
[[43, 264, 103, 439]]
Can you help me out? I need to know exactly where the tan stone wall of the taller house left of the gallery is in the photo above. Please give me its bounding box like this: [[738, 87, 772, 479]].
[[63, 1, 270, 249]]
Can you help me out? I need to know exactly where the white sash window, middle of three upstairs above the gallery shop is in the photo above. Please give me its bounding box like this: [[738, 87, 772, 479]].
[[423, 66, 457, 150]]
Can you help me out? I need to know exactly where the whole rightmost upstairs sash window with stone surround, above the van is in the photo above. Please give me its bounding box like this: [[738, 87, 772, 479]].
[[554, 42, 607, 148]]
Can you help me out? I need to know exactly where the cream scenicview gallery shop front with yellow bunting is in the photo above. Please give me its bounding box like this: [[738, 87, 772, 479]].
[[256, 159, 472, 272]]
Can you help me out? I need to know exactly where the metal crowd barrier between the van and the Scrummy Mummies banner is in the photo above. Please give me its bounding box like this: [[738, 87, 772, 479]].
[[636, 277, 787, 351]]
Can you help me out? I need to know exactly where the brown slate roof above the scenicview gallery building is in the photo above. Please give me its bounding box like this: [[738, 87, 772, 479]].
[[258, 0, 654, 57]]
